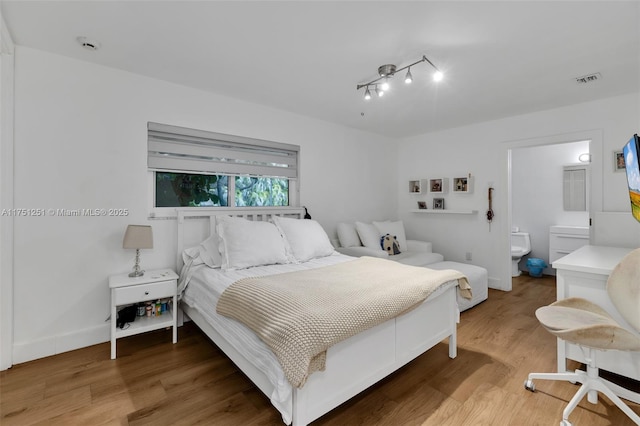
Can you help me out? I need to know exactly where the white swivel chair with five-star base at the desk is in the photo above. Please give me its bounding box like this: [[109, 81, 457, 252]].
[[524, 249, 640, 426]]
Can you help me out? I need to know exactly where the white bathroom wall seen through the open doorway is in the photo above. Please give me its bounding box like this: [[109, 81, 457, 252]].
[[511, 141, 589, 273]]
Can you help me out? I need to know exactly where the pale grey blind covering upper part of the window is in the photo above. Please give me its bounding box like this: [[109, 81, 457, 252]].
[[147, 122, 300, 179]]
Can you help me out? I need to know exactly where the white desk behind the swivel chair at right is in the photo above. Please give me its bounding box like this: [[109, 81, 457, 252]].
[[552, 246, 640, 402]]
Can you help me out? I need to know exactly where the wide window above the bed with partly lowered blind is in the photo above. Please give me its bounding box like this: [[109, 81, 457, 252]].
[[147, 123, 300, 210]]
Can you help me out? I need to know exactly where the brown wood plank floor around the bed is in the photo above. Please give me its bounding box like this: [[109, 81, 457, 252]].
[[0, 276, 640, 426]]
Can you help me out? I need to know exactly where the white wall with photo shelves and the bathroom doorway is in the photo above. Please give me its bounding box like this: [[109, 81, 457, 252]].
[[396, 93, 640, 288]]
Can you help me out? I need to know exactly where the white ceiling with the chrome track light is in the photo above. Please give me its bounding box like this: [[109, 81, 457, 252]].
[[0, 0, 640, 138]]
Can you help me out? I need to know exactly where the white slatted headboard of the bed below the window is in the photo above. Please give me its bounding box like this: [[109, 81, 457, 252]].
[[176, 207, 305, 271]]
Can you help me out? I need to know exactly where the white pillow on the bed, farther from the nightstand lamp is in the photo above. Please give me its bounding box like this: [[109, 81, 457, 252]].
[[272, 216, 335, 262]]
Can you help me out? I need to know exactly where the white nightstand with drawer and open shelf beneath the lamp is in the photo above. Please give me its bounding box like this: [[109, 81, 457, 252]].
[[109, 269, 178, 359]]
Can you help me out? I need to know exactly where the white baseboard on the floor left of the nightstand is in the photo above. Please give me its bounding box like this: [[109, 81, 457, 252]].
[[13, 323, 111, 364]]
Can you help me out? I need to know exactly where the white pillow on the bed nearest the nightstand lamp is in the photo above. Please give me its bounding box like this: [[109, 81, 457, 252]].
[[217, 218, 289, 270]]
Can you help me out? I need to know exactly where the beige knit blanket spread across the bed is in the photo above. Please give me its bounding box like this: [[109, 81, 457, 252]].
[[216, 257, 471, 387]]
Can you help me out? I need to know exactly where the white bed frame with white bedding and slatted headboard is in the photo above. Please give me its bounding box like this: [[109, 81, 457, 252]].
[[177, 207, 464, 426]]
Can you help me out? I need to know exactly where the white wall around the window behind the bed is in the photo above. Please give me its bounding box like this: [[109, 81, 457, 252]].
[[14, 47, 397, 363]]
